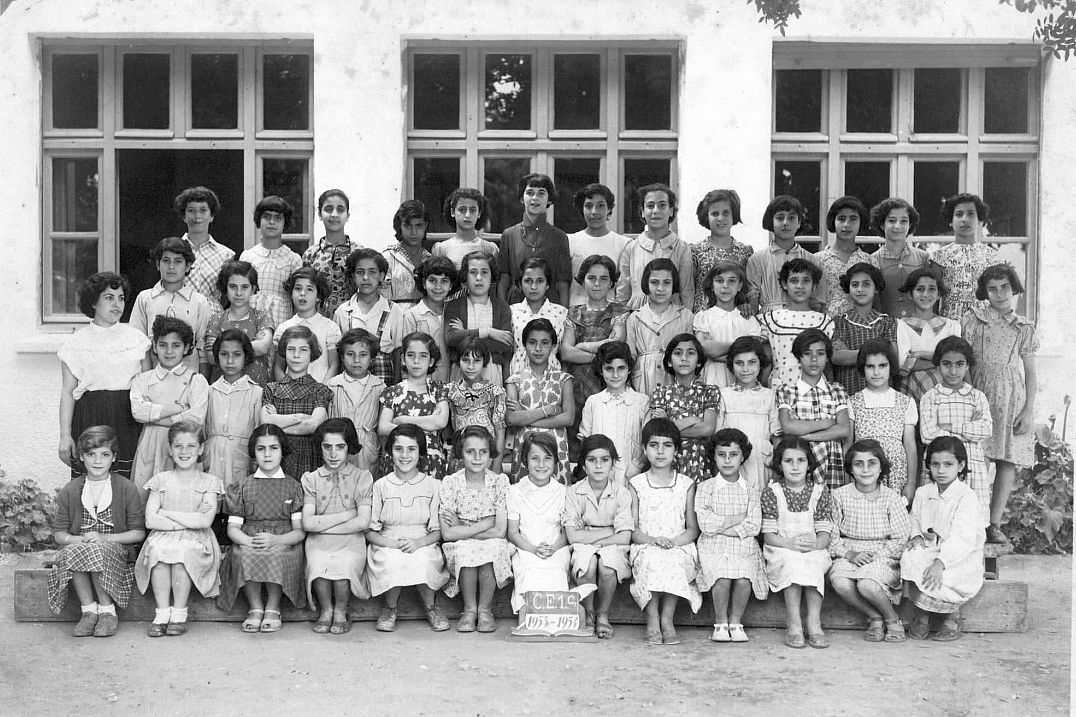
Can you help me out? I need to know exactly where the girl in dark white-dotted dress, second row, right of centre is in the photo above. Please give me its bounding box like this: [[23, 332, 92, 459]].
[[650, 334, 721, 483]]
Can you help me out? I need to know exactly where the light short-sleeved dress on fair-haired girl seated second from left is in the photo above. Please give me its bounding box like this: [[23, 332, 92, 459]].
[[135, 470, 224, 598]]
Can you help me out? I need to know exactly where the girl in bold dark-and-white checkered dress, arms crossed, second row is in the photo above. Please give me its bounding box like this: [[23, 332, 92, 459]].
[[777, 328, 851, 490]]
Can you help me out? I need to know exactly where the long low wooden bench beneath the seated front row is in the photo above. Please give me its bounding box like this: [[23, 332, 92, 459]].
[[15, 568, 1028, 632]]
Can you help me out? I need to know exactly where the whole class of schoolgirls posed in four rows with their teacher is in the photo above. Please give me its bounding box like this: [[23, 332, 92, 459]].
[[51, 175, 1035, 647]]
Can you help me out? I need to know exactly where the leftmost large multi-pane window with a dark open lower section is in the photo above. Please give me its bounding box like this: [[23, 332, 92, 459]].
[[42, 43, 313, 322]]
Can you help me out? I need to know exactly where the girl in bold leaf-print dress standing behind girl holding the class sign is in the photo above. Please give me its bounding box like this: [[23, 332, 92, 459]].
[[505, 319, 576, 484]]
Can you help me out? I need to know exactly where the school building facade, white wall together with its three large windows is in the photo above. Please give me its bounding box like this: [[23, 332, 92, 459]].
[[0, 0, 1076, 487]]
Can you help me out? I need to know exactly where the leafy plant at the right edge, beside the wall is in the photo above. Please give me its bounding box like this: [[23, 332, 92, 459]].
[[1002, 418, 1073, 554]]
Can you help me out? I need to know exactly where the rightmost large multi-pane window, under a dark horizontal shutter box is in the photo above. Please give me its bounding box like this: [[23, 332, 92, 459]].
[[771, 42, 1039, 312]]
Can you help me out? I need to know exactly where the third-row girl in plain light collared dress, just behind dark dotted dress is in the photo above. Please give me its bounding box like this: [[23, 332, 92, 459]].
[[624, 258, 694, 396]]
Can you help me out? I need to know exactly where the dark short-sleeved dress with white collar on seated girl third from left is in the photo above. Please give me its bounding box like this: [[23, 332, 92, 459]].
[[216, 469, 307, 610]]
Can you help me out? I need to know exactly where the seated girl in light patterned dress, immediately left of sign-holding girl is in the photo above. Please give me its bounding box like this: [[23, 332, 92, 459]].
[[438, 426, 512, 632]]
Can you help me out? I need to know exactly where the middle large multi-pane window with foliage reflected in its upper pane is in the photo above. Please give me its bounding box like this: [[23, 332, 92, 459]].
[[405, 42, 679, 238]]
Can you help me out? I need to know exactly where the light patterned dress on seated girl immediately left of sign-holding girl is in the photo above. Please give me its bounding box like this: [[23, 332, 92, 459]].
[[438, 470, 512, 598]]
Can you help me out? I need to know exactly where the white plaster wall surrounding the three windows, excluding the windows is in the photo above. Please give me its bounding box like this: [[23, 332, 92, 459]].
[[0, 0, 1076, 486]]
